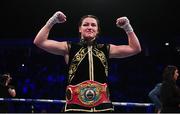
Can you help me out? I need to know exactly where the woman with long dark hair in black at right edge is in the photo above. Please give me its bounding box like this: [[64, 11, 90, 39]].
[[160, 65, 180, 113]]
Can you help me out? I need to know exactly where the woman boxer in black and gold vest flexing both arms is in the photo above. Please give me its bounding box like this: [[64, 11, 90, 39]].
[[34, 11, 141, 112]]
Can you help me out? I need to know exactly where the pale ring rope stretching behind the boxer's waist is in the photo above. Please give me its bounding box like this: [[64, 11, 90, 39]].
[[0, 98, 154, 113]]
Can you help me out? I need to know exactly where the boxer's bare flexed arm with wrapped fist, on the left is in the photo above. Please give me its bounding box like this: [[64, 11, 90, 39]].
[[34, 11, 68, 56]]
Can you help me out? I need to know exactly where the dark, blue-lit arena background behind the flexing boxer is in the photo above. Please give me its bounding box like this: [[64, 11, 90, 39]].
[[0, 0, 180, 112]]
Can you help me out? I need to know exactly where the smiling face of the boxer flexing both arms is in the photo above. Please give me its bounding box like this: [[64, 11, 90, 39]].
[[79, 17, 98, 40]]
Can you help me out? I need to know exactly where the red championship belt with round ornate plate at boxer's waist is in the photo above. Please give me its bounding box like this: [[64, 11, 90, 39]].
[[66, 80, 110, 107]]
